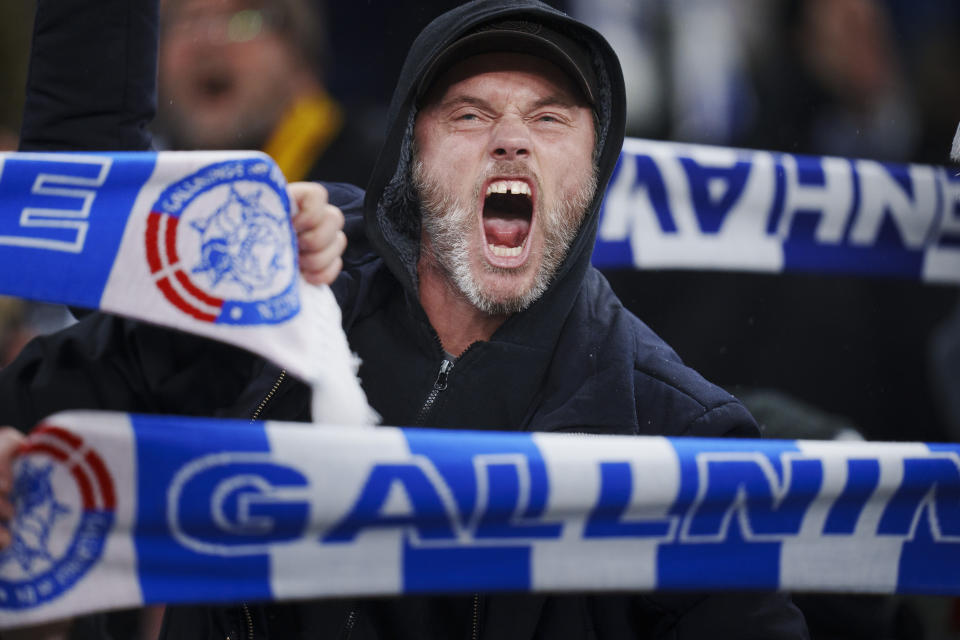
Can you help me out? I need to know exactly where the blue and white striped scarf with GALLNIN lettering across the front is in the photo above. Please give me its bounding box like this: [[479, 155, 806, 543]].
[[0, 412, 960, 628]]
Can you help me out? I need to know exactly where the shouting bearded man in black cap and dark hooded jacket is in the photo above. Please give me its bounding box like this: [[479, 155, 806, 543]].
[[0, 0, 806, 640]]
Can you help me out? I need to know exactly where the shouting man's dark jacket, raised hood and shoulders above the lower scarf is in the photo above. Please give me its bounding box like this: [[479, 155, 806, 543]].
[[335, 0, 757, 436]]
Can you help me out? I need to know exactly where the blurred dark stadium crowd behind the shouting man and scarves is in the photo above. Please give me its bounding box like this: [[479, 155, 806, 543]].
[[0, 0, 960, 639]]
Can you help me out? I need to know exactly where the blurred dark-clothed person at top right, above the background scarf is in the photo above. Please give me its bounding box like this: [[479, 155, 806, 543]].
[[742, 0, 920, 162]]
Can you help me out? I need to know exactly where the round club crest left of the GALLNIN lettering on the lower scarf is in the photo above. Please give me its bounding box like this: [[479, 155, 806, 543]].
[[0, 426, 116, 609]]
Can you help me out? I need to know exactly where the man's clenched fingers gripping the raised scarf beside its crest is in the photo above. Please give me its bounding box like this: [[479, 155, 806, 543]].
[[290, 182, 347, 284]]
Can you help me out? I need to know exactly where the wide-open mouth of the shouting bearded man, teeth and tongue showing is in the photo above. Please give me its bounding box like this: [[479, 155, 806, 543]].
[[483, 179, 533, 259]]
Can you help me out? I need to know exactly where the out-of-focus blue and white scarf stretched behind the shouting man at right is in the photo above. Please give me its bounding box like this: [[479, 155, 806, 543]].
[[593, 139, 960, 284]]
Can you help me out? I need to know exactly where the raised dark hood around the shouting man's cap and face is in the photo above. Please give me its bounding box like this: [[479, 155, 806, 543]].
[[364, 0, 626, 330]]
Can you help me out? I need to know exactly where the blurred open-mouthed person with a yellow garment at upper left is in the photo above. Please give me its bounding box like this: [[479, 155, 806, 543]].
[[157, 0, 380, 185]]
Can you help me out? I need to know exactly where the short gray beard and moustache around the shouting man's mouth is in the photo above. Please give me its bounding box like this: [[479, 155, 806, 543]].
[[413, 159, 597, 315]]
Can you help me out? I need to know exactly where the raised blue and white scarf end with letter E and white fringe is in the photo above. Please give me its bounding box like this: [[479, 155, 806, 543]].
[[0, 152, 375, 424]]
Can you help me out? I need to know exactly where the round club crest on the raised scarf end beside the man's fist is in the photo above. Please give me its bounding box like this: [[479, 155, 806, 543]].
[[146, 158, 300, 325]]
